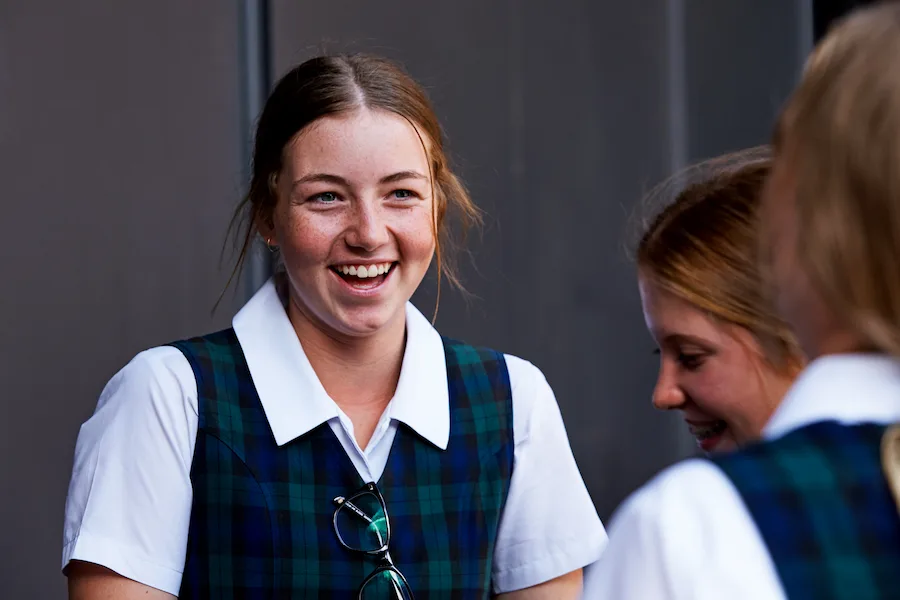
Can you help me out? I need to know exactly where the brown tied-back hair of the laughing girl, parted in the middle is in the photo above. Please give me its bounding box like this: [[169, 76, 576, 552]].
[[222, 54, 481, 313]]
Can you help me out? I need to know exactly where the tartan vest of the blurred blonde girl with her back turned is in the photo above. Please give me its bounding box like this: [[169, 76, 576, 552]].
[[712, 421, 900, 600]]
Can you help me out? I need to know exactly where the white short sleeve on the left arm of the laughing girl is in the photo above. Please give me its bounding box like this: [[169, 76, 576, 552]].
[[62, 347, 198, 595]]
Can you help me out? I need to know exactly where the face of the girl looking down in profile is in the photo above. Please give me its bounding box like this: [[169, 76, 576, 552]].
[[639, 275, 791, 452]]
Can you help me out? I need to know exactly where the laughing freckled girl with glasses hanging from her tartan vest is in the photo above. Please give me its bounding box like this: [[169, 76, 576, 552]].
[[63, 56, 606, 600]]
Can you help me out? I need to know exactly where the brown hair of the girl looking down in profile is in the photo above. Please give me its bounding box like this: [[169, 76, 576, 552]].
[[636, 149, 802, 370]]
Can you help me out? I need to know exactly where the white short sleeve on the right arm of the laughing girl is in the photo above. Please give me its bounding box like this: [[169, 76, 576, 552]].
[[493, 356, 606, 593]]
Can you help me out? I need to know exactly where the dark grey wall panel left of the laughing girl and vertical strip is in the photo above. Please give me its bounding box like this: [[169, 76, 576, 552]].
[[0, 0, 240, 600]]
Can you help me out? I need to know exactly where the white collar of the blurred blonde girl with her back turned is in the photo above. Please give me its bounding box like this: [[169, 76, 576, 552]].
[[763, 354, 900, 439]]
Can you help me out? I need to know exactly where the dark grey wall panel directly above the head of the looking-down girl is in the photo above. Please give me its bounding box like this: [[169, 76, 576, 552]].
[[682, 0, 812, 160]]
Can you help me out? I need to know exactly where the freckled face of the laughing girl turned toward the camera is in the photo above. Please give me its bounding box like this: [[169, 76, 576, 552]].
[[261, 108, 435, 339]]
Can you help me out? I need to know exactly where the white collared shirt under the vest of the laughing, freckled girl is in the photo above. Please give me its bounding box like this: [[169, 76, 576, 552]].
[[62, 280, 606, 595]]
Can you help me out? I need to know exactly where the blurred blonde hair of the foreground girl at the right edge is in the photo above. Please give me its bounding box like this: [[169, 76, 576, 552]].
[[775, 2, 900, 355]]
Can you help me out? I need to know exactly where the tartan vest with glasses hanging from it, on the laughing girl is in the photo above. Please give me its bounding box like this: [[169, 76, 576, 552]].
[[173, 329, 514, 600]]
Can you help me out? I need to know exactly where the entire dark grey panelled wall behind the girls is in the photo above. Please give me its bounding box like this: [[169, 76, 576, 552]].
[[0, 0, 811, 599]]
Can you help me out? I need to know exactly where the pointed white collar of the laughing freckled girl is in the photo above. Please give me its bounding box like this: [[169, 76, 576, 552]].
[[232, 279, 450, 450]]
